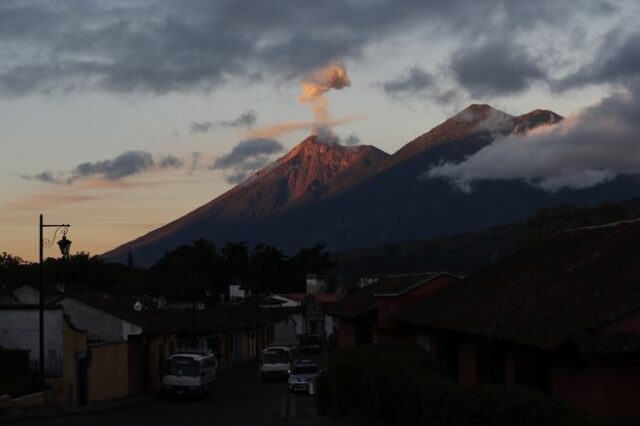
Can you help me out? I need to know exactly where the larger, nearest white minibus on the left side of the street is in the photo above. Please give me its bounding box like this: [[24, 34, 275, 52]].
[[160, 350, 218, 396]]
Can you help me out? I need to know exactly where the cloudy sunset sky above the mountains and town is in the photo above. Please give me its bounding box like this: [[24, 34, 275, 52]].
[[0, 0, 640, 260]]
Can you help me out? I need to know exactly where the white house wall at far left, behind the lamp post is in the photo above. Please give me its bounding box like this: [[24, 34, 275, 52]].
[[0, 309, 64, 365]]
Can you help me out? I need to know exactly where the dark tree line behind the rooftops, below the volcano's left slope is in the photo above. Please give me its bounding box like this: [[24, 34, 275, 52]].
[[0, 239, 333, 301]]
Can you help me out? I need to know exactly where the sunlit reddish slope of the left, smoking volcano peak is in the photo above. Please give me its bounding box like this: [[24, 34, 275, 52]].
[[103, 136, 389, 264]]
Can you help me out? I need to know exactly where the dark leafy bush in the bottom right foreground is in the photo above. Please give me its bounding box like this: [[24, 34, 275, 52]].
[[317, 345, 637, 426]]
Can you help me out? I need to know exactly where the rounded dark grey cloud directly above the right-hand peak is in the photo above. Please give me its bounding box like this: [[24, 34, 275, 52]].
[[450, 40, 546, 98]]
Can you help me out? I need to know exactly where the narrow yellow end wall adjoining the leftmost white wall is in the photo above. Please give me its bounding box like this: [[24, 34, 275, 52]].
[[62, 319, 87, 406]]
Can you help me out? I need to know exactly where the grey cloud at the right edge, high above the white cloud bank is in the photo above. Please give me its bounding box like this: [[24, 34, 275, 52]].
[[555, 31, 640, 91]]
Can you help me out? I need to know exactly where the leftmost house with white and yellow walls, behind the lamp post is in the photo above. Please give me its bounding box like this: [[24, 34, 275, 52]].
[[0, 304, 88, 406]]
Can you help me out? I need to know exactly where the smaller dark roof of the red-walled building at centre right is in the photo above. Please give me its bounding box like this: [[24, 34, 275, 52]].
[[329, 273, 441, 319]]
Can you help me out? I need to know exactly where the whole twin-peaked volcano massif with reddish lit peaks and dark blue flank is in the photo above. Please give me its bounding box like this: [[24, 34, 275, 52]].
[[103, 104, 640, 266]]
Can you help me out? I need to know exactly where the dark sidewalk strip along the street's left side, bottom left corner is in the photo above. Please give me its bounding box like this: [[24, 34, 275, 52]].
[[0, 394, 158, 424]]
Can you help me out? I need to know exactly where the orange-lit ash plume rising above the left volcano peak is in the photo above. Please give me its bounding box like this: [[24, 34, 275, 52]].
[[298, 61, 351, 124]]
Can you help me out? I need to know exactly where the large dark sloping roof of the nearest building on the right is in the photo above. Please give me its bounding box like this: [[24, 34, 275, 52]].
[[397, 223, 640, 349]]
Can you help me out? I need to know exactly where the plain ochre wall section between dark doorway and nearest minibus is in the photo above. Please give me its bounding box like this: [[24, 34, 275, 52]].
[[89, 342, 129, 402]]
